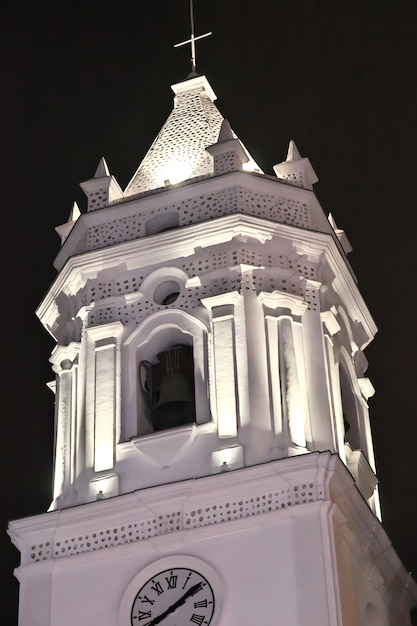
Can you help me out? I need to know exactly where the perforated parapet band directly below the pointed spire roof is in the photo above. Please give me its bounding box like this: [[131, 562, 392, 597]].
[[54, 168, 328, 269]]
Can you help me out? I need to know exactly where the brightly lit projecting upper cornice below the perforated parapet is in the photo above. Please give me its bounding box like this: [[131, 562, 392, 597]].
[[36, 212, 377, 348]]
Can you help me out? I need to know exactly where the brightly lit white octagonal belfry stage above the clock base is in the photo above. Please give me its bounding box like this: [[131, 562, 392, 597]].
[[38, 79, 378, 513]]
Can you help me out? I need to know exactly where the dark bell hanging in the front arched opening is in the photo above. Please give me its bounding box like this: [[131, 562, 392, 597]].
[[141, 345, 196, 430]]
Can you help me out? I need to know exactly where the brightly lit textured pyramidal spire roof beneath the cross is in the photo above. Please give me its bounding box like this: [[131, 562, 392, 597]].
[[124, 76, 260, 197]]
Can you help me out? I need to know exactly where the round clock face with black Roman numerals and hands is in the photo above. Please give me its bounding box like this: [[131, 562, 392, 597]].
[[130, 567, 215, 626]]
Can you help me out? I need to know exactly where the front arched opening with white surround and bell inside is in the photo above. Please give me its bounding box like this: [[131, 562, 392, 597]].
[[121, 308, 212, 441]]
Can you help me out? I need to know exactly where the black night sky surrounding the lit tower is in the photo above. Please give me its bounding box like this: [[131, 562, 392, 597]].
[[0, 0, 417, 626]]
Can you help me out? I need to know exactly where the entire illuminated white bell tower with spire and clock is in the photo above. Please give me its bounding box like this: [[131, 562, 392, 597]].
[[9, 72, 417, 626]]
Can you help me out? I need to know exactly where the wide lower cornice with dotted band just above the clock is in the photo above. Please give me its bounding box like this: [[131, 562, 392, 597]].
[[8, 452, 417, 605]]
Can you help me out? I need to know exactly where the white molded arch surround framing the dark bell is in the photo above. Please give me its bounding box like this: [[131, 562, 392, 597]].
[[122, 309, 211, 440]]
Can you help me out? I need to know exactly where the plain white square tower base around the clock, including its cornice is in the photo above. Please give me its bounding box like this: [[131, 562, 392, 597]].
[[8, 453, 415, 626]]
